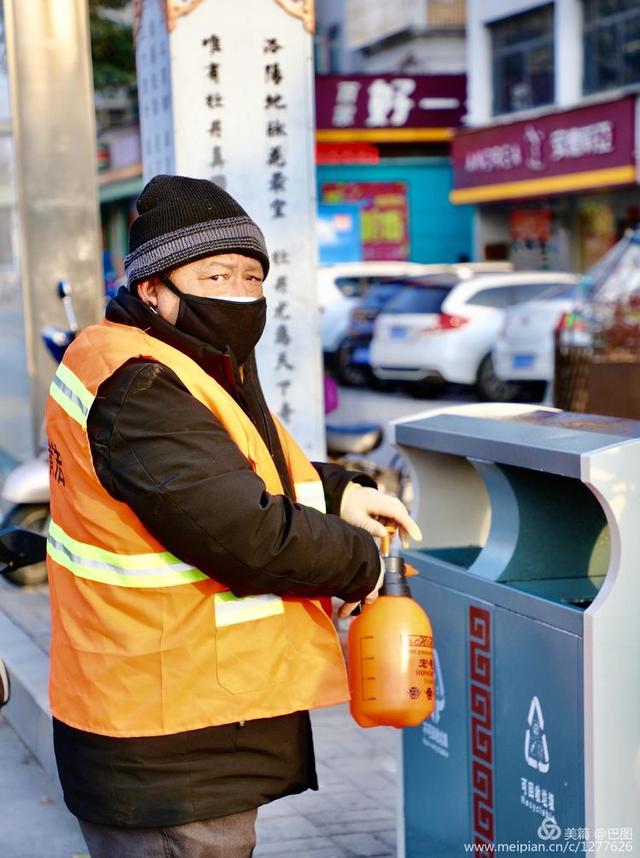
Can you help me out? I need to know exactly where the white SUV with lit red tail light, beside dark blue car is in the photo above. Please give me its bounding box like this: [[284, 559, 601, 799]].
[[370, 271, 575, 402]]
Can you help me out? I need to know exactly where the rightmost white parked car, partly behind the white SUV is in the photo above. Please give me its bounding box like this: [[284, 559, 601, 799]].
[[493, 274, 580, 384]]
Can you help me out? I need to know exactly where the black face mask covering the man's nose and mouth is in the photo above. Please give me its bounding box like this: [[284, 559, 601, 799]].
[[160, 274, 267, 364]]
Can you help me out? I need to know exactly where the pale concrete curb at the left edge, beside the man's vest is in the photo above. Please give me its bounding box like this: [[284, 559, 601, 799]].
[[0, 611, 58, 782]]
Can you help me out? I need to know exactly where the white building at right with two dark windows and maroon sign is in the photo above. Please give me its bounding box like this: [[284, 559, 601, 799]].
[[458, 0, 640, 271]]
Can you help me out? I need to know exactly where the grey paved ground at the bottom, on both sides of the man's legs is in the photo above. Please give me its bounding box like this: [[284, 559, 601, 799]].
[[0, 706, 399, 858]]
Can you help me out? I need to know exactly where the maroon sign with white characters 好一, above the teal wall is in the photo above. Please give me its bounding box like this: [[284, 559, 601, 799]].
[[316, 74, 467, 140]]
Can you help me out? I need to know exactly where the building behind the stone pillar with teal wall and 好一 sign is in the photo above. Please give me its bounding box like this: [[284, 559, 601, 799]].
[[315, 0, 472, 262]]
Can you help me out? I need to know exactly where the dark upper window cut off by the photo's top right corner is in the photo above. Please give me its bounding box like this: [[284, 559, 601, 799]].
[[584, 0, 640, 93]]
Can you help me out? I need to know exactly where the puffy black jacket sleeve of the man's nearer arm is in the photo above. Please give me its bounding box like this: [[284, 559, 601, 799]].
[[87, 360, 380, 602]]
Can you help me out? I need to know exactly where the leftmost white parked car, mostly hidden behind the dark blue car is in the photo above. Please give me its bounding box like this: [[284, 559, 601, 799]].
[[318, 261, 438, 381]]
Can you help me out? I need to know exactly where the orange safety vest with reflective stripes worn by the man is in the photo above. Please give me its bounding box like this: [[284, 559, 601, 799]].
[[47, 322, 349, 736]]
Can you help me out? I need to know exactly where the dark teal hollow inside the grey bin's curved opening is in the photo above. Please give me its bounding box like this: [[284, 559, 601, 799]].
[[408, 460, 611, 610]]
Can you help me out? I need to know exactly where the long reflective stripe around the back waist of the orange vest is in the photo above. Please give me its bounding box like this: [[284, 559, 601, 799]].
[[47, 521, 207, 587]]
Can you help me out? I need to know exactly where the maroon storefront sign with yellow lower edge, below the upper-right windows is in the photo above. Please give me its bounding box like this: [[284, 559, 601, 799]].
[[451, 97, 636, 203]]
